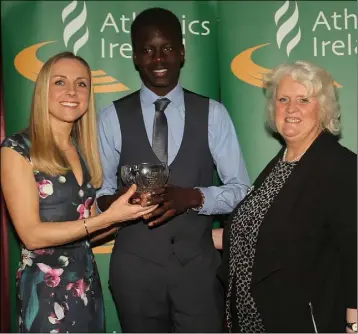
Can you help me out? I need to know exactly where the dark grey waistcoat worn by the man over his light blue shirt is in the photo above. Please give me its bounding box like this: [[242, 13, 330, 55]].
[[113, 90, 214, 264]]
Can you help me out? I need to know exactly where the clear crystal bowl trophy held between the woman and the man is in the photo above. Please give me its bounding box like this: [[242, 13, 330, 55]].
[[121, 162, 169, 193]]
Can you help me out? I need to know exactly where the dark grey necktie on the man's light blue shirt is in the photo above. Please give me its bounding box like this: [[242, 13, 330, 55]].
[[152, 98, 170, 163]]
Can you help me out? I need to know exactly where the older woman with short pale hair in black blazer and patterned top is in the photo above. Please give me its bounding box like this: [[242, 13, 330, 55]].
[[219, 61, 357, 333]]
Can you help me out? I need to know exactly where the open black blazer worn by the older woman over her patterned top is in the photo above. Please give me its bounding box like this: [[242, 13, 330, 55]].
[[218, 132, 357, 333]]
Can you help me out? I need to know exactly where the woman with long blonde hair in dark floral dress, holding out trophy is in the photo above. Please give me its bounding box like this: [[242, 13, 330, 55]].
[[1, 52, 156, 332]]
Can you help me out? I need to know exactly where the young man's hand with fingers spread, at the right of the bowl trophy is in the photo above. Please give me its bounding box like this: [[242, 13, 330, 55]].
[[143, 185, 203, 227]]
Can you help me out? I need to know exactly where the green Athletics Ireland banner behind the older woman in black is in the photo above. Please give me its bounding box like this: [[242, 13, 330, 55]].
[[218, 1, 357, 180]]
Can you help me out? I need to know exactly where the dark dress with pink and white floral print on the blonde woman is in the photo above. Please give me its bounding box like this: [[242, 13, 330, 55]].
[[2, 133, 104, 333]]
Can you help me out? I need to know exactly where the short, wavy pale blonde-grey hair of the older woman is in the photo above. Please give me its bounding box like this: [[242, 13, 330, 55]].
[[264, 61, 341, 135]]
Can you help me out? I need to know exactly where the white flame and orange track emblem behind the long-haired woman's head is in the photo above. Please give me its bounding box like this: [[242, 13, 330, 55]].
[[14, 1, 129, 93]]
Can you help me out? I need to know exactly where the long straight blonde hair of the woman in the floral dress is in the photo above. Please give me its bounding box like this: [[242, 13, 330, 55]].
[[29, 52, 102, 188]]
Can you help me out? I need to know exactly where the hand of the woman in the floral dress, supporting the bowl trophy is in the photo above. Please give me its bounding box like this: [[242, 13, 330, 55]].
[[105, 184, 158, 223]]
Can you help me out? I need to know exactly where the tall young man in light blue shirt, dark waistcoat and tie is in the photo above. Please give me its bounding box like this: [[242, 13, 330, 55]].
[[98, 8, 249, 333]]
